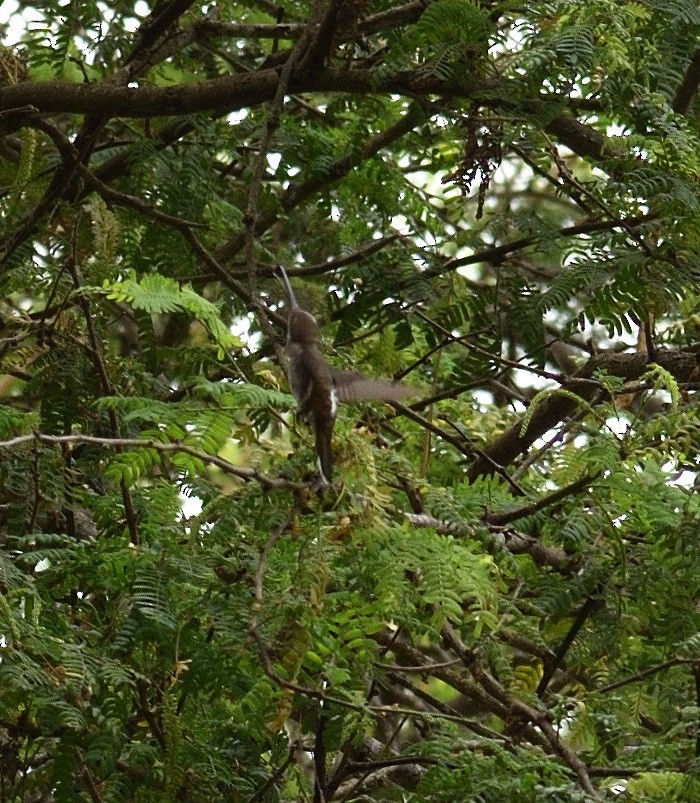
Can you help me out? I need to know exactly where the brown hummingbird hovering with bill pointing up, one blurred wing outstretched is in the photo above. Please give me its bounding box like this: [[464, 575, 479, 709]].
[[279, 266, 415, 485]]
